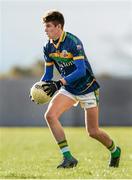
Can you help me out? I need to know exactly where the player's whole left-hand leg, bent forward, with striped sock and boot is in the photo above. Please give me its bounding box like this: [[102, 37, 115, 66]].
[[45, 94, 77, 168]]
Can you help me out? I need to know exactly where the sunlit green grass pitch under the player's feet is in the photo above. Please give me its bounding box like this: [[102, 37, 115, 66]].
[[0, 128, 132, 179]]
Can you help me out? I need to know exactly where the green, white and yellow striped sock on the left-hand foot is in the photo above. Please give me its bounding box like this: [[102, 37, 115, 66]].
[[58, 140, 72, 159]]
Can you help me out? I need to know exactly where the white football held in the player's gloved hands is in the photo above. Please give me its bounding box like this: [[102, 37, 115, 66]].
[[30, 81, 51, 104]]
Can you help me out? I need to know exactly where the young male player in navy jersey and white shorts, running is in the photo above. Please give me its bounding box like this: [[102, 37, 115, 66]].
[[41, 11, 121, 168]]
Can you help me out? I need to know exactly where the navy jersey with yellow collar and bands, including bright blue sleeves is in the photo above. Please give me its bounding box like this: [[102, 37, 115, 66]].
[[41, 31, 99, 95]]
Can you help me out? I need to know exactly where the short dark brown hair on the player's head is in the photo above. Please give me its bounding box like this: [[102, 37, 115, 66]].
[[43, 11, 65, 29]]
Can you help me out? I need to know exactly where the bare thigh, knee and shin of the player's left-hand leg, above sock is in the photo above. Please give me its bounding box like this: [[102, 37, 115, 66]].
[[45, 94, 75, 142]]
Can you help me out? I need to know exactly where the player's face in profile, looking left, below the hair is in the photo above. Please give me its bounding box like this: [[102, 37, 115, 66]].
[[45, 22, 60, 39]]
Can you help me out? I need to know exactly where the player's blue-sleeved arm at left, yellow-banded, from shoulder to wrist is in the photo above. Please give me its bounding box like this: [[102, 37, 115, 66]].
[[41, 47, 54, 81]]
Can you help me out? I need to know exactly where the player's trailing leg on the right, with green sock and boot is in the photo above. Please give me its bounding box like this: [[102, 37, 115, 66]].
[[85, 107, 121, 167]]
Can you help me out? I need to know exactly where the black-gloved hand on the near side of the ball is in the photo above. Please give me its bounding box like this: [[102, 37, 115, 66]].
[[42, 80, 63, 97]]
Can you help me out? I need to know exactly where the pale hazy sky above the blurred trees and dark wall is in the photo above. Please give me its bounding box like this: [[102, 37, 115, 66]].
[[0, 0, 132, 76]]
